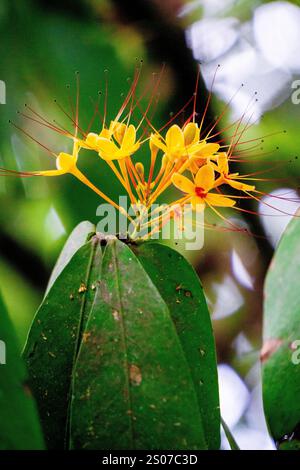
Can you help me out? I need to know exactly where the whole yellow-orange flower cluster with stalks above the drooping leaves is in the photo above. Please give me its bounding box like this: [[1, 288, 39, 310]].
[[0, 73, 256, 239]]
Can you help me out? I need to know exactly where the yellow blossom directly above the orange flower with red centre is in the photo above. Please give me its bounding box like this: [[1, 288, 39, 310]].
[[151, 122, 220, 162]]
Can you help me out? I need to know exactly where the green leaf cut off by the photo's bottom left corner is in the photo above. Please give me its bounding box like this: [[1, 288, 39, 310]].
[[0, 296, 44, 450]]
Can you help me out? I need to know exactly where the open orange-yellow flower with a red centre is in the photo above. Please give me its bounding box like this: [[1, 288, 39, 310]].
[[172, 165, 235, 211]]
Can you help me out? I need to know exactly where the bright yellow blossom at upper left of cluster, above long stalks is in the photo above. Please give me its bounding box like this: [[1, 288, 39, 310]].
[[83, 121, 140, 161]]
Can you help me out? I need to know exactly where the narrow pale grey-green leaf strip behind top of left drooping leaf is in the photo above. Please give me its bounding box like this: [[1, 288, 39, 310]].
[[45, 221, 95, 295]]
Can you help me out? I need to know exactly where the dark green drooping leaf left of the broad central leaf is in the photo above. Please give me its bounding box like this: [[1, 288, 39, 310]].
[[24, 237, 102, 449]]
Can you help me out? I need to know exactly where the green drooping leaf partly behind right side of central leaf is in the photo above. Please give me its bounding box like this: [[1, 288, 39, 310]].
[[135, 243, 220, 449]]
